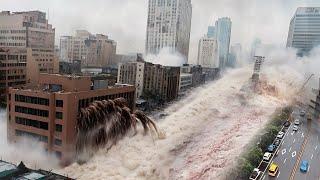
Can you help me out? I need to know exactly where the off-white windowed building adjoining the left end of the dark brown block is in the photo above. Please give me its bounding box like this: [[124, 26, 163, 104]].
[[117, 62, 145, 98]]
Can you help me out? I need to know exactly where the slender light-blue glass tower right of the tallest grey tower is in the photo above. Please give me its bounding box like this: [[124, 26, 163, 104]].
[[215, 17, 232, 69]]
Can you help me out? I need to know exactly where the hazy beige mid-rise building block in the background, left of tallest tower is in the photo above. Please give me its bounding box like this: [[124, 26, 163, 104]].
[[60, 30, 117, 67]]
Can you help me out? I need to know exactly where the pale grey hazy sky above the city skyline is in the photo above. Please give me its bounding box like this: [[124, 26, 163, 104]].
[[0, 0, 320, 61]]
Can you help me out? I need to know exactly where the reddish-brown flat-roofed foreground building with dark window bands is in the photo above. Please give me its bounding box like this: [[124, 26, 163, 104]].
[[7, 74, 135, 165]]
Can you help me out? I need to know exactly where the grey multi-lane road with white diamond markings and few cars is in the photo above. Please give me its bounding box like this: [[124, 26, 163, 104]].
[[265, 109, 320, 180]]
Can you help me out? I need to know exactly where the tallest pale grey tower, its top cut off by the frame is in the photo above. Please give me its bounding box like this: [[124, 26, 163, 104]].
[[146, 0, 192, 59]]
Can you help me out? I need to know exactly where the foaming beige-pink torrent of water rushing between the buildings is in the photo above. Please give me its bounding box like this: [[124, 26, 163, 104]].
[[59, 67, 302, 179]]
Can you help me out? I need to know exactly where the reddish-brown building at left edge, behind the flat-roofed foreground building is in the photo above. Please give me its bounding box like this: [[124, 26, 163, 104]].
[[0, 48, 27, 103]]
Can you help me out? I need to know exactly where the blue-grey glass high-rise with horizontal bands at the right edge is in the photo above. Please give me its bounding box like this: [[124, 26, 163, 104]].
[[287, 7, 320, 56]]
